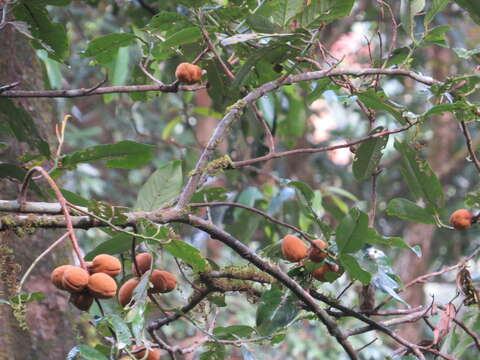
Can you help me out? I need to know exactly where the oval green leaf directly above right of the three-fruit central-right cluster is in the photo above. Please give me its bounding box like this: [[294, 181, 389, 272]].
[[335, 208, 368, 254]]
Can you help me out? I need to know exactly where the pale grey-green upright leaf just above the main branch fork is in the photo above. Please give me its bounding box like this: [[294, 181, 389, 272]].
[[135, 160, 183, 211]]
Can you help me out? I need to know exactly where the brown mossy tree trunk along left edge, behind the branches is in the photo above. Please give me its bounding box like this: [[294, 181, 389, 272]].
[[0, 25, 78, 360]]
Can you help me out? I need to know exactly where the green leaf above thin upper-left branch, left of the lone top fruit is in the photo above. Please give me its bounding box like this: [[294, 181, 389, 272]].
[[82, 33, 137, 64]]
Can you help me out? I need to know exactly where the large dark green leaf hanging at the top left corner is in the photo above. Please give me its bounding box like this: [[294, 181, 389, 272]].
[[13, 0, 69, 63]]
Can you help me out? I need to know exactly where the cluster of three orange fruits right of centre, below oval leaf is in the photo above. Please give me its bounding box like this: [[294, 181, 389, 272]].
[[282, 235, 340, 282]]
